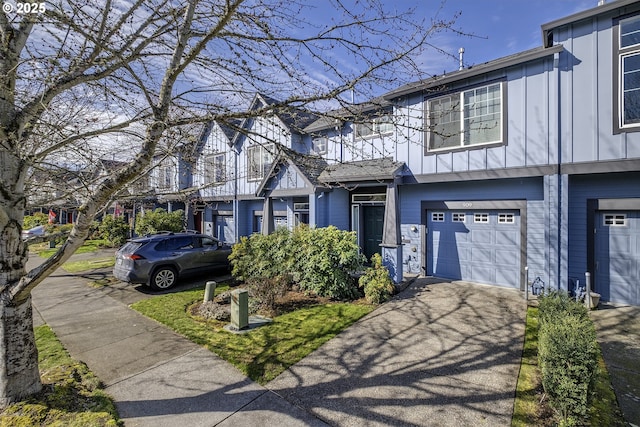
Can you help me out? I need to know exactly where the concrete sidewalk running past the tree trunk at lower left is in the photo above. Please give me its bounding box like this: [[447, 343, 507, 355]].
[[32, 254, 326, 427]]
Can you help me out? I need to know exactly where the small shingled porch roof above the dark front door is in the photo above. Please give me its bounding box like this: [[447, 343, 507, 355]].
[[318, 157, 404, 184]]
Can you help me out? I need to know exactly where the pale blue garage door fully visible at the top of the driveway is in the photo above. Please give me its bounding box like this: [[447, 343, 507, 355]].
[[426, 210, 520, 288]]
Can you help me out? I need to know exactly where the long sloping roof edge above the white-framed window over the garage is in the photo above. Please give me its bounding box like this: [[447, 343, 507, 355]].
[[383, 45, 563, 100]]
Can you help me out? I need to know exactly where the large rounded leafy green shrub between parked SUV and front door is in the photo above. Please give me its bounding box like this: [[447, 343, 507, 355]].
[[229, 226, 364, 300]]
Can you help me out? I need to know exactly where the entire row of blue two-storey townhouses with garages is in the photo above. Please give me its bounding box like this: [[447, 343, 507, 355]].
[[188, 0, 640, 305]]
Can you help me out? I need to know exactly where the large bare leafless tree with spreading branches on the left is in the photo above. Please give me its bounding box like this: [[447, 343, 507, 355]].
[[0, 0, 450, 406]]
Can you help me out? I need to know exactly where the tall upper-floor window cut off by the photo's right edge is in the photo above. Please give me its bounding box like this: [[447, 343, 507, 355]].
[[615, 16, 640, 131]]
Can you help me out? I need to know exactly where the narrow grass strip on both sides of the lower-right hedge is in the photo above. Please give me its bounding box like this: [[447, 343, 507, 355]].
[[511, 307, 627, 427]]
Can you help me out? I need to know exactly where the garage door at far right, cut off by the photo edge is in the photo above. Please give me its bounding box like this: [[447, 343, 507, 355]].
[[595, 211, 640, 305]]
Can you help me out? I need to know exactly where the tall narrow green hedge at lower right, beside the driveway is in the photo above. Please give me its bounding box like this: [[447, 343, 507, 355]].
[[538, 292, 600, 426]]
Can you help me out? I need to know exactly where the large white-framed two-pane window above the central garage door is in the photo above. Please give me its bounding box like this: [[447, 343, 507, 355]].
[[426, 83, 506, 151]]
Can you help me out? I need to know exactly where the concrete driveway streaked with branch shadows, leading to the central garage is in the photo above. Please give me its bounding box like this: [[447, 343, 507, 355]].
[[267, 278, 526, 426]]
